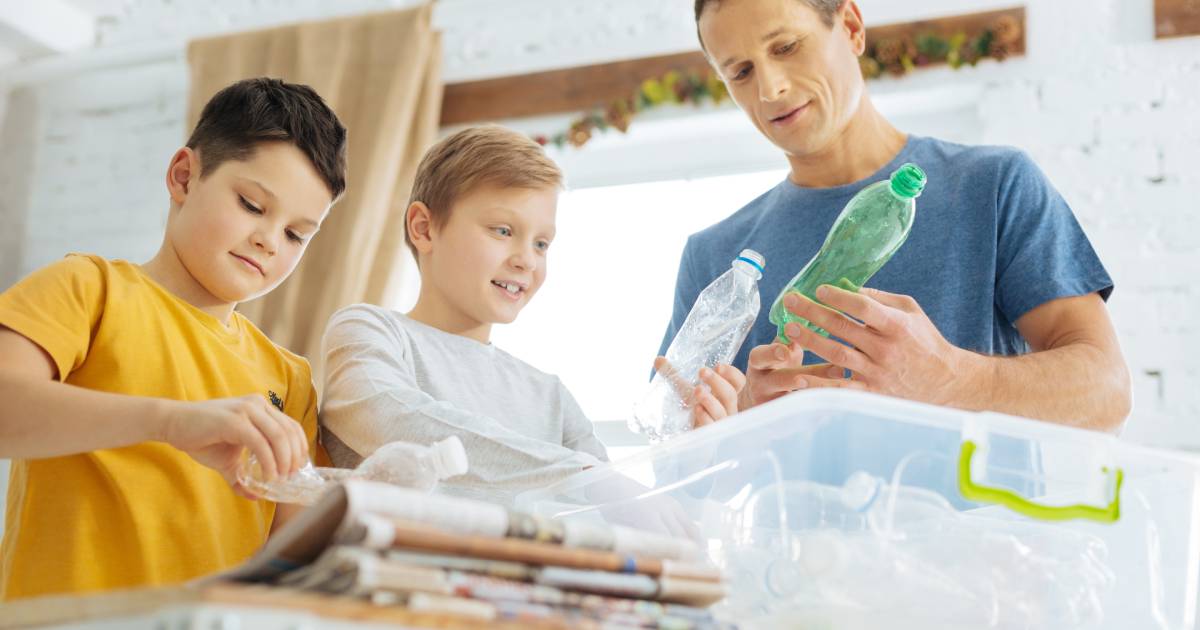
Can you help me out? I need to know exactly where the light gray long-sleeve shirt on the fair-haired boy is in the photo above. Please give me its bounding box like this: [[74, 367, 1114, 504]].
[[320, 305, 607, 504]]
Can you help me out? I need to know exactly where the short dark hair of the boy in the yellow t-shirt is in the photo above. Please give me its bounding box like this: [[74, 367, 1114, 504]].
[[187, 77, 346, 200]]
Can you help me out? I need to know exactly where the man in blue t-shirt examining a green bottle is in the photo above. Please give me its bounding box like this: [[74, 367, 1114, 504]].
[[660, 0, 1130, 431]]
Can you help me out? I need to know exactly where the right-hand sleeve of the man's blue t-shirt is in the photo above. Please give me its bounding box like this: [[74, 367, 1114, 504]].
[[996, 152, 1112, 323]]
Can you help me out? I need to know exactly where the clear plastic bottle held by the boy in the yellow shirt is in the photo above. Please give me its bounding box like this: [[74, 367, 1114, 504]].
[[238, 436, 467, 505]]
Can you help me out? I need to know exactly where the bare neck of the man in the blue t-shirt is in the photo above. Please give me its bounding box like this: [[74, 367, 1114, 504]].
[[787, 92, 907, 188]]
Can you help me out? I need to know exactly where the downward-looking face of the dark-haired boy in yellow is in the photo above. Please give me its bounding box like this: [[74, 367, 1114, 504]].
[[167, 142, 332, 302]]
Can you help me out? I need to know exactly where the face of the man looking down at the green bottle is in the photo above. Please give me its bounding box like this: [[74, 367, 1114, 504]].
[[698, 0, 863, 157]]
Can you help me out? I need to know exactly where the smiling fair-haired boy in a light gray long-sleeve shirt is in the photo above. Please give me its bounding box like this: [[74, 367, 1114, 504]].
[[320, 126, 745, 504]]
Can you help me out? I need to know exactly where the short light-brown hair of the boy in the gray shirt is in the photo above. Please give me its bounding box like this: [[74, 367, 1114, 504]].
[[404, 125, 563, 258]]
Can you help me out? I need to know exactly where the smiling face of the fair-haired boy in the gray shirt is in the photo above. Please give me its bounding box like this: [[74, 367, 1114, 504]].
[[421, 186, 558, 325]]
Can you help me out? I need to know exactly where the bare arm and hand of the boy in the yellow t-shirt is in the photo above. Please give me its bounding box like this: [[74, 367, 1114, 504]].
[[0, 326, 307, 484]]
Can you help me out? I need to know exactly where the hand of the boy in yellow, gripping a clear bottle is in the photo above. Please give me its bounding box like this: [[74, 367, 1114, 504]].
[[160, 395, 308, 498]]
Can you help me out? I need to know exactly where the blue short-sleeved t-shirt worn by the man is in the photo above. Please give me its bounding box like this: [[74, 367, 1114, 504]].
[[659, 136, 1112, 371]]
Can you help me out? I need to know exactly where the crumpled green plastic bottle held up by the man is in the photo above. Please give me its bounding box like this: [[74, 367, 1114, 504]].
[[768, 163, 925, 343]]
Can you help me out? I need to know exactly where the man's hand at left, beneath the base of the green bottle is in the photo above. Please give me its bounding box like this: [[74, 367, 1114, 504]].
[[738, 342, 864, 412]]
